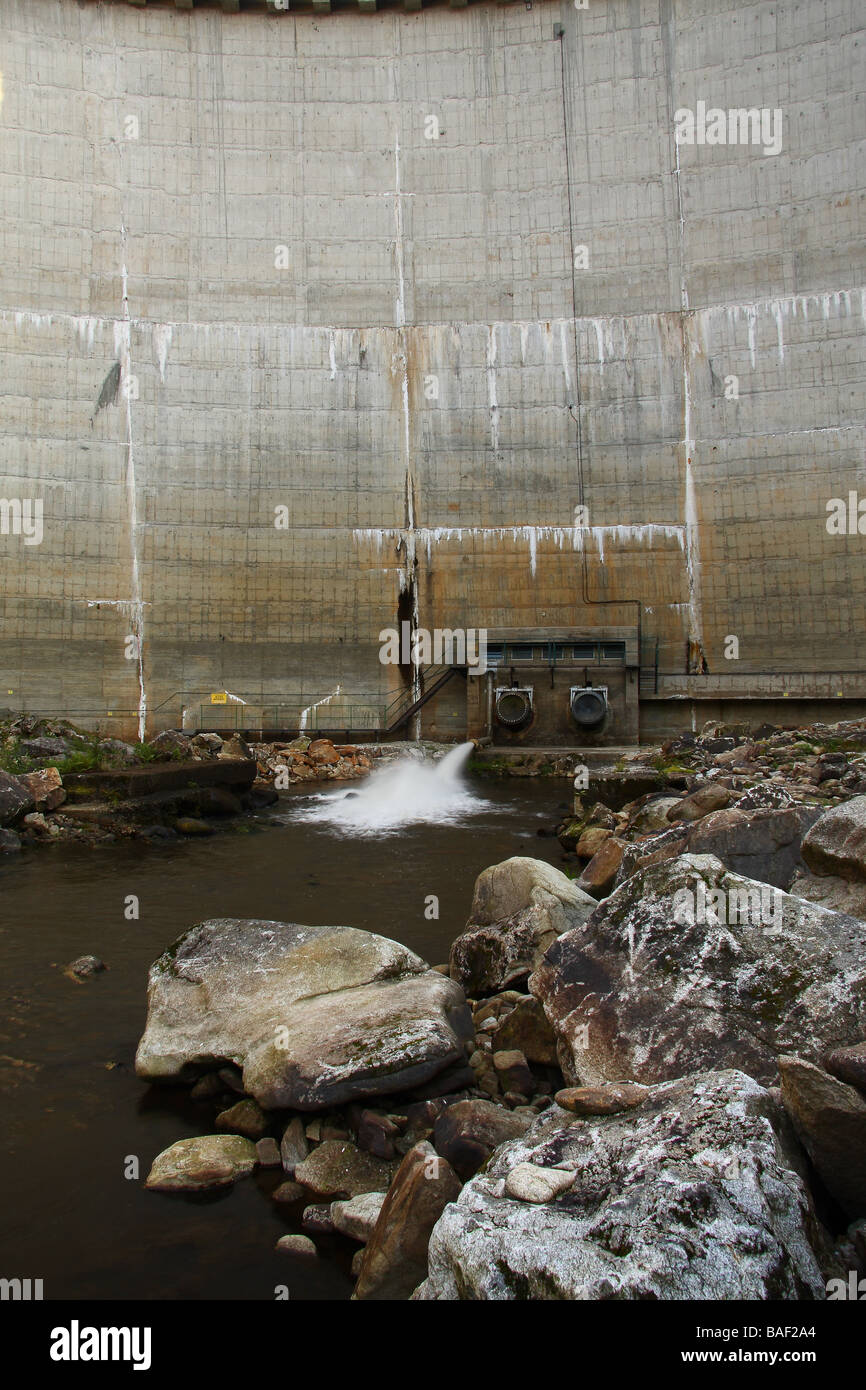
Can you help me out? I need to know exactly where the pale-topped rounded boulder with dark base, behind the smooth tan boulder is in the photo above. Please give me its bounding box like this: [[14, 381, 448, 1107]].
[[449, 855, 595, 995]]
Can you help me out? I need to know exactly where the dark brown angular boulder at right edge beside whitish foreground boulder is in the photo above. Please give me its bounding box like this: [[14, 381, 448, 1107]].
[[778, 1056, 866, 1218]]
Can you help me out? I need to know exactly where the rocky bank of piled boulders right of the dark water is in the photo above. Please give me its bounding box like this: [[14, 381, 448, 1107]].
[[130, 726, 866, 1301]]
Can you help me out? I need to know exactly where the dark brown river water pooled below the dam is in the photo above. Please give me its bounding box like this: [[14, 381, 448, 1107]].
[[0, 769, 571, 1300]]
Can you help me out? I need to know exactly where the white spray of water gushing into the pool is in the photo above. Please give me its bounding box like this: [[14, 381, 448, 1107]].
[[292, 744, 488, 835]]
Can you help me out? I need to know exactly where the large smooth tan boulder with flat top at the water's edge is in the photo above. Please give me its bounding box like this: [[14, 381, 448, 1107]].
[[136, 917, 471, 1111]]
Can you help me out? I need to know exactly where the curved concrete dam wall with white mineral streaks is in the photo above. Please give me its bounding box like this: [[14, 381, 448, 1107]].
[[0, 0, 866, 742]]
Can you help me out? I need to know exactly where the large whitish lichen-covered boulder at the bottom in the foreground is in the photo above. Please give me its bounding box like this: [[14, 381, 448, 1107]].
[[414, 1072, 824, 1301]]
